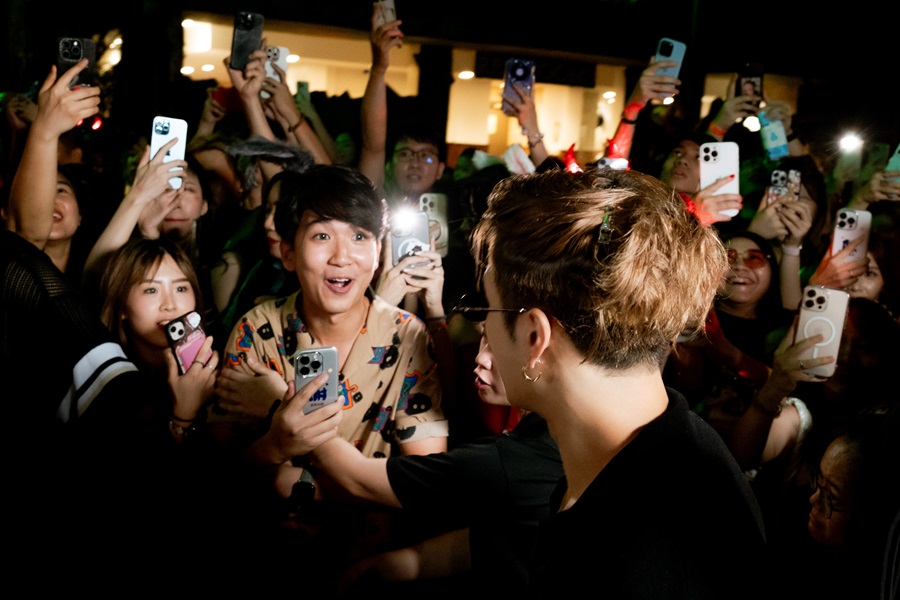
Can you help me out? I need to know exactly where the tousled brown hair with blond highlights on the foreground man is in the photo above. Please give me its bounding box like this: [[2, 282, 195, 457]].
[[472, 168, 727, 369]]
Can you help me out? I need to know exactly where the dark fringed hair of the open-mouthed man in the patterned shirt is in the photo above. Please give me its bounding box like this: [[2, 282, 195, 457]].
[[275, 164, 387, 243]]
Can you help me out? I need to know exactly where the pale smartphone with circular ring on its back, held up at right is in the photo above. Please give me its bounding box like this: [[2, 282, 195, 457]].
[[794, 285, 850, 377]]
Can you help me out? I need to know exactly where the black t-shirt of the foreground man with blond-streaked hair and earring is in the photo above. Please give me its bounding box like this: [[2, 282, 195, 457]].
[[528, 388, 771, 600]]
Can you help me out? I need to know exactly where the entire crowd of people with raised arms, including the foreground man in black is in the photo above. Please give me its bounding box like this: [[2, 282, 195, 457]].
[[0, 7, 900, 600]]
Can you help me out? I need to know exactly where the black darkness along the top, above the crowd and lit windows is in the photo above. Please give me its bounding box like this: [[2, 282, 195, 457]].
[[0, 0, 900, 158]]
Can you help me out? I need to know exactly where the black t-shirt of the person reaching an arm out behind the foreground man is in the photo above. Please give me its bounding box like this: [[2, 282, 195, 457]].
[[387, 413, 563, 593]]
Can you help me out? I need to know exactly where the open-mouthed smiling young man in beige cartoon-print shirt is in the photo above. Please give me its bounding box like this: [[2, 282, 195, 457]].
[[211, 165, 448, 458]]
